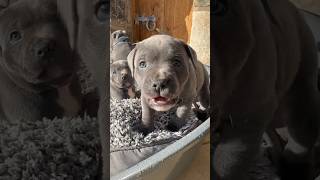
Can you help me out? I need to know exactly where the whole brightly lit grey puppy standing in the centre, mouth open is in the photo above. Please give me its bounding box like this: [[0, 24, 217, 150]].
[[128, 35, 210, 133]]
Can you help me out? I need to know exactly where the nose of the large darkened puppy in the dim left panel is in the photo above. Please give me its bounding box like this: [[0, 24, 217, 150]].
[[32, 39, 54, 58]]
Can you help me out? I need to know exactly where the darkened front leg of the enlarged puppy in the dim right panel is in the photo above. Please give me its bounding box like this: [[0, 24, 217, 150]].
[[211, 100, 275, 180]]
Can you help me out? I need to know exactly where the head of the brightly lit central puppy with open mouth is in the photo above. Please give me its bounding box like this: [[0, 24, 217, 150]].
[[128, 35, 196, 111]]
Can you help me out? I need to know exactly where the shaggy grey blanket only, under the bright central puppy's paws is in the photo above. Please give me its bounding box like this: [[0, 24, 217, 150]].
[[110, 99, 200, 152]]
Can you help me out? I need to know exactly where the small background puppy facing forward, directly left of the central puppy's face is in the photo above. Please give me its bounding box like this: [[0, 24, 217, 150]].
[[110, 60, 135, 100]]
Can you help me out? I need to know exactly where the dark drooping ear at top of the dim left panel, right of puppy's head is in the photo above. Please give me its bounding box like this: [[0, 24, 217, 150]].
[[57, 0, 78, 49]]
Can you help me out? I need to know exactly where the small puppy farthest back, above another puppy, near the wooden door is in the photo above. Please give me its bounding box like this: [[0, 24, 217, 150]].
[[110, 30, 134, 63]]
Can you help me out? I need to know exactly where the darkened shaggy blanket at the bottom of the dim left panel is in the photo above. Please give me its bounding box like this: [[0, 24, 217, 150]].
[[0, 117, 100, 180]]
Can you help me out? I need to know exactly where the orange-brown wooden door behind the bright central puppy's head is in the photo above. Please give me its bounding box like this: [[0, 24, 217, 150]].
[[131, 0, 193, 42]]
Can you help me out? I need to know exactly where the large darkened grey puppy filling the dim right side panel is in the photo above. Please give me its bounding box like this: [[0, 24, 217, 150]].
[[211, 0, 320, 180]]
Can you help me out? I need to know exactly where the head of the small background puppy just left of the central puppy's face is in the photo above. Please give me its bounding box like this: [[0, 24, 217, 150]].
[[110, 60, 134, 89]]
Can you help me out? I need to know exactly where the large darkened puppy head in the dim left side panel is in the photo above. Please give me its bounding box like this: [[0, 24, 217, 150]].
[[0, 0, 76, 92]]
